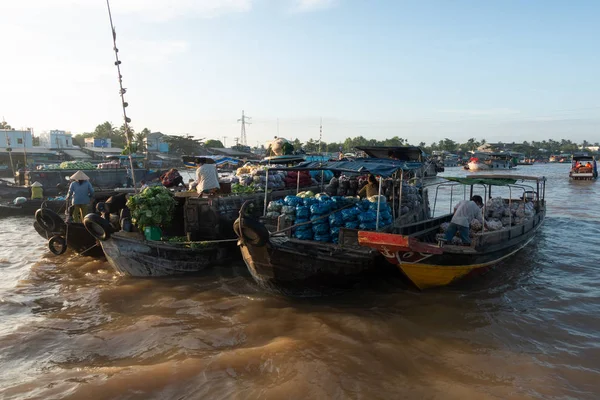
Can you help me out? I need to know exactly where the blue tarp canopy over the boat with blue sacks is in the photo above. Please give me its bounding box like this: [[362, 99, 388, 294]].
[[270, 158, 423, 178]]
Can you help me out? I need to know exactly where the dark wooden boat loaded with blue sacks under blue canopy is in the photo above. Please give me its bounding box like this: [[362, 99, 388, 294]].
[[234, 158, 428, 296]]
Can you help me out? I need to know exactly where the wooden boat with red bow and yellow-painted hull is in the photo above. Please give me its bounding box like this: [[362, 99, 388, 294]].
[[358, 175, 546, 289]]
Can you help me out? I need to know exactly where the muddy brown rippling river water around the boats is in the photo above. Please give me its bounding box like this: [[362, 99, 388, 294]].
[[0, 164, 600, 400]]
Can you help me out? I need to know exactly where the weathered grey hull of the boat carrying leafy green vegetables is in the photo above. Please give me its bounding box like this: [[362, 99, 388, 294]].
[[101, 232, 239, 277]]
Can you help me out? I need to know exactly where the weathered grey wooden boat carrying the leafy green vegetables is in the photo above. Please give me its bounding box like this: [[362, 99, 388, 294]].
[[90, 190, 314, 277]]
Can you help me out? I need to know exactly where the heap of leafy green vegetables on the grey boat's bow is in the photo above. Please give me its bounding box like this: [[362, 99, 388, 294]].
[[127, 186, 175, 231]]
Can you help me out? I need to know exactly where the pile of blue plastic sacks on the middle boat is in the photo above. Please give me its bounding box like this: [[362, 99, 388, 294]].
[[266, 192, 392, 243]]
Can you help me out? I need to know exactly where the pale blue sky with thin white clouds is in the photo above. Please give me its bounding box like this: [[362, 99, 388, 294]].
[[0, 0, 600, 146]]
